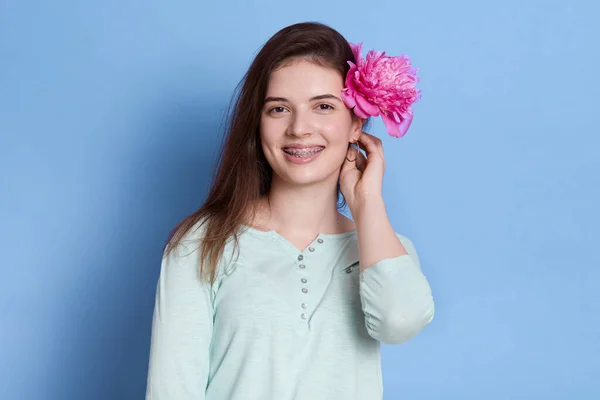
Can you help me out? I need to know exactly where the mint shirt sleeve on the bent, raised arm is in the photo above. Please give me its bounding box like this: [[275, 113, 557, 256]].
[[360, 235, 434, 344]]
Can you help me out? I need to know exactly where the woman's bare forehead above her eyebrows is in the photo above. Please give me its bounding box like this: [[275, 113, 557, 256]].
[[267, 60, 344, 99]]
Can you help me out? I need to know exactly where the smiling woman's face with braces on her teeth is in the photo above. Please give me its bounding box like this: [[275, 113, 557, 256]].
[[260, 60, 362, 189]]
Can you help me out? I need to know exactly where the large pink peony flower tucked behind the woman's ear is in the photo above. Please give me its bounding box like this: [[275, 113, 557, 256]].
[[342, 43, 421, 137]]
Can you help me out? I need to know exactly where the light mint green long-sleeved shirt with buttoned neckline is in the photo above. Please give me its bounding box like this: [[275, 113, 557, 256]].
[[146, 223, 434, 400]]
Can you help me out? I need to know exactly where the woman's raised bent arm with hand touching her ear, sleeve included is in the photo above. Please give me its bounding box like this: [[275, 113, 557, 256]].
[[340, 132, 434, 343]]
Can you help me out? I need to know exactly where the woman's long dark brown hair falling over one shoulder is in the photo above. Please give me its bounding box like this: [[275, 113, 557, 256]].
[[165, 22, 355, 282]]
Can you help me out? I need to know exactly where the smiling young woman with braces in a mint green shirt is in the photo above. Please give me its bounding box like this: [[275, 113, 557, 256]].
[[146, 23, 434, 400]]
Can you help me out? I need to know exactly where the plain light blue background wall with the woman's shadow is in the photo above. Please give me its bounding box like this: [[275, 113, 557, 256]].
[[0, 0, 600, 400]]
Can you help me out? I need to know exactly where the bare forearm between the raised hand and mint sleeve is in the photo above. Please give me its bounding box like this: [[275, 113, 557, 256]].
[[351, 197, 407, 271]]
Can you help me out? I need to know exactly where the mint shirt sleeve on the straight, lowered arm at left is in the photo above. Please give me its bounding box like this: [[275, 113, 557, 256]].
[[146, 245, 213, 400]]
